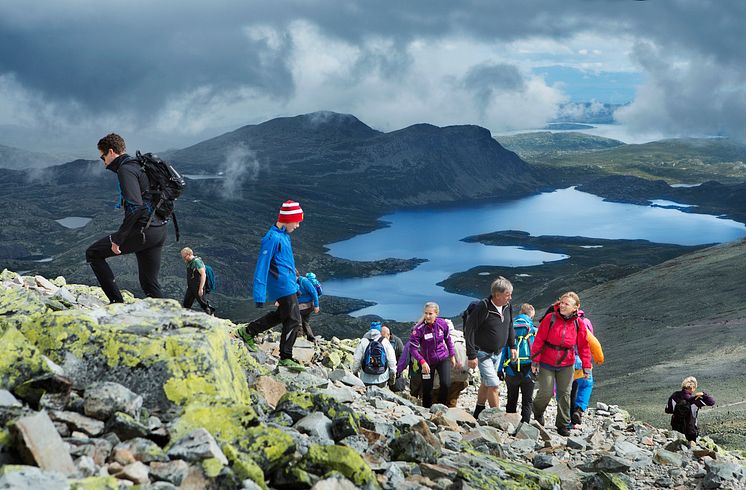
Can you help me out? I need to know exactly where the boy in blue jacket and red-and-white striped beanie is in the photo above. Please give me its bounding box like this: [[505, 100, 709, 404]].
[[238, 201, 303, 370]]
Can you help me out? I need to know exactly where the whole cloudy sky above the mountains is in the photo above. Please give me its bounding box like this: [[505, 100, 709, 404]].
[[0, 0, 746, 158]]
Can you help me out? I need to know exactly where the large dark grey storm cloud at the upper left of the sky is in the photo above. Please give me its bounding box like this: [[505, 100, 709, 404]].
[[0, 3, 293, 111]]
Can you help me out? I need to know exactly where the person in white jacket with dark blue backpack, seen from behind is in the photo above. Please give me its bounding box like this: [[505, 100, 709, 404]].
[[352, 322, 396, 388]]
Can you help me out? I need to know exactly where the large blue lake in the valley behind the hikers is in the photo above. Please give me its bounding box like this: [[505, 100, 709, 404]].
[[324, 188, 746, 321]]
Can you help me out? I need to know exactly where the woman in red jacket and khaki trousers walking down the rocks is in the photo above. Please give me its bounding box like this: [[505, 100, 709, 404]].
[[531, 291, 591, 436]]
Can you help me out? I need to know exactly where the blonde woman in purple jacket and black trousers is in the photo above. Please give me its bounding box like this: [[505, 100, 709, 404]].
[[409, 303, 457, 408]]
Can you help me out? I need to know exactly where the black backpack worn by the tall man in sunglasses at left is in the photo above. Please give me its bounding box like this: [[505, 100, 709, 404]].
[[135, 150, 186, 242]]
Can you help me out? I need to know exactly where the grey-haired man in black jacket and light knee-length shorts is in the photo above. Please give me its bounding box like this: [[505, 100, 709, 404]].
[[464, 276, 518, 418]]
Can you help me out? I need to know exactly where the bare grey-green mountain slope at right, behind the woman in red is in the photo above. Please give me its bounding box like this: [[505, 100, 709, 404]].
[[580, 241, 746, 447]]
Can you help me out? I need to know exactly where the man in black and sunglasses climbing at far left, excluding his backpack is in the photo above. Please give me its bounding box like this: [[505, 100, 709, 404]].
[[85, 133, 166, 303]]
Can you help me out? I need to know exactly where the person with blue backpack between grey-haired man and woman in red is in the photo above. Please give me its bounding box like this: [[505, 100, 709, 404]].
[[497, 303, 536, 423]]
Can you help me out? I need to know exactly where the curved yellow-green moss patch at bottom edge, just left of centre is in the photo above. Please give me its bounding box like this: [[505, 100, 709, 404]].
[[301, 444, 378, 488]]
